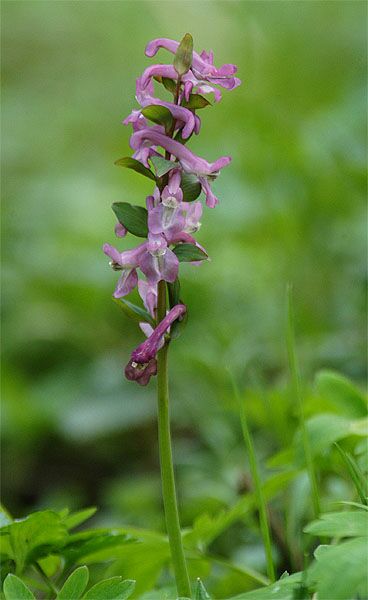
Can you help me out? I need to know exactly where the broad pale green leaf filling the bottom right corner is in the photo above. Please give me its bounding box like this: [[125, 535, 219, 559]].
[[308, 538, 368, 600]]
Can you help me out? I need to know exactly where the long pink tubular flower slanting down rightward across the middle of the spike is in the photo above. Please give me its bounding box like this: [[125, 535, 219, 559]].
[[130, 127, 231, 208]]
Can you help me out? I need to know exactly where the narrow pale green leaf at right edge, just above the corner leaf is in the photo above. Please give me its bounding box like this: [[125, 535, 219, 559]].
[[304, 510, 368, 537]]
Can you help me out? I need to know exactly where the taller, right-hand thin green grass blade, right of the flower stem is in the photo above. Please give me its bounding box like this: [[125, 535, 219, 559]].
[[286, 284, 321, 518]]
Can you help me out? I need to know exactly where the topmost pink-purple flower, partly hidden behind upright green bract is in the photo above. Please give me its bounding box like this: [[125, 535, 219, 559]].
[[146, 38, 241, 90]]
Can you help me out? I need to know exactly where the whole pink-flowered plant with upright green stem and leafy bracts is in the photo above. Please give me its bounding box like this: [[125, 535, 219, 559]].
[[103, 34, 240, 597]]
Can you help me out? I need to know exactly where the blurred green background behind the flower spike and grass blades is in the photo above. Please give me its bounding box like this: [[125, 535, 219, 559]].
[[2, 0, 366, 556]]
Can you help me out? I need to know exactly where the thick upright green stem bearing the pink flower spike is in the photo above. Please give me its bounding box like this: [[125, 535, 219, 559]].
[[157, 281, 191, 598]]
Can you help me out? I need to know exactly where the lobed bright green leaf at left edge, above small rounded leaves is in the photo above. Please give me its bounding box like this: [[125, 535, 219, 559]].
[[1, 510, 67, 573]]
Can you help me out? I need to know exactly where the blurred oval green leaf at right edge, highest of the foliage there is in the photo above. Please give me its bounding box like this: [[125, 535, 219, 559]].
[[316, 370, 368, 418]]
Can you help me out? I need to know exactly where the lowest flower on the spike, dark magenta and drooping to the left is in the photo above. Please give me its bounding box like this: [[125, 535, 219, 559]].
[[125, 304, 187, 385]]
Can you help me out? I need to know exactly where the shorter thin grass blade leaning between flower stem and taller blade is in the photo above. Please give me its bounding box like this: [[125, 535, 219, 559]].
[[230, 373, 275, 581]]
